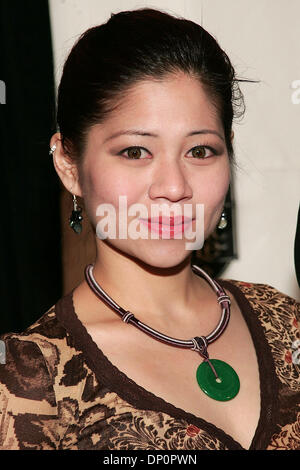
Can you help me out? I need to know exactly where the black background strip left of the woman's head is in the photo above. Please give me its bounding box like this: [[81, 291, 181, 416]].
[[0, 0, 62, 334]]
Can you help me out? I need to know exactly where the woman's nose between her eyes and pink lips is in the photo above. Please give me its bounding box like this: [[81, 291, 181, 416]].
[[149, 159, 193, 202]]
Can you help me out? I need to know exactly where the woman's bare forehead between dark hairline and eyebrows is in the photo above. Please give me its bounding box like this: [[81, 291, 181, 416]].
[[89, 73, 222, 135]]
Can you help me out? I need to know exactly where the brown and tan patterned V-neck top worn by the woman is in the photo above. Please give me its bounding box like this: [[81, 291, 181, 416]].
[[0, 279, 300, 450]]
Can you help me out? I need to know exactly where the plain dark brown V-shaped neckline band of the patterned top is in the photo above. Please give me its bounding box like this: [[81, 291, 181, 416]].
[[55, 279, 278, 450]]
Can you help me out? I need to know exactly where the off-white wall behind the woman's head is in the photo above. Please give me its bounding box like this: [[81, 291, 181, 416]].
[[49, 0, 300, 300]]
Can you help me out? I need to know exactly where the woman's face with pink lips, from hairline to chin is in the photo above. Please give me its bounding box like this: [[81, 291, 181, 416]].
[[77, 73, 230, 267]]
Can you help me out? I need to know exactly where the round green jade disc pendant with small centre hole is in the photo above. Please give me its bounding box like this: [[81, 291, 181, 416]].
[[196, 359, 240, 401]]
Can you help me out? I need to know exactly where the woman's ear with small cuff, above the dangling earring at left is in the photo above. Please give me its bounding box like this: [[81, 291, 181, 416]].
[[50, 132, 82, 197]]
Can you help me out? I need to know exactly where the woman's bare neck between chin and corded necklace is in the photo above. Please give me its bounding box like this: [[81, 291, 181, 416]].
[[79, 239, 214, 325]]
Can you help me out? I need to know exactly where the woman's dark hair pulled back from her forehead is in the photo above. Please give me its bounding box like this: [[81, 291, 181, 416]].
[[57, 8, 248, 176]]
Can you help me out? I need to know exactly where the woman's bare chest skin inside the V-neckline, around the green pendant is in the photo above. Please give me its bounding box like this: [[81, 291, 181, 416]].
[[74, 284, 260, 449]]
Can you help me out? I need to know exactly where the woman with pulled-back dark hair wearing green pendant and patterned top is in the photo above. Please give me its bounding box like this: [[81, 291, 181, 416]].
[[0, 9, 300, 450]]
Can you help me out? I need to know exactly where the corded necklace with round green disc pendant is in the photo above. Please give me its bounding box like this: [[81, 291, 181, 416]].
[[84, 264, 240, 401]]
